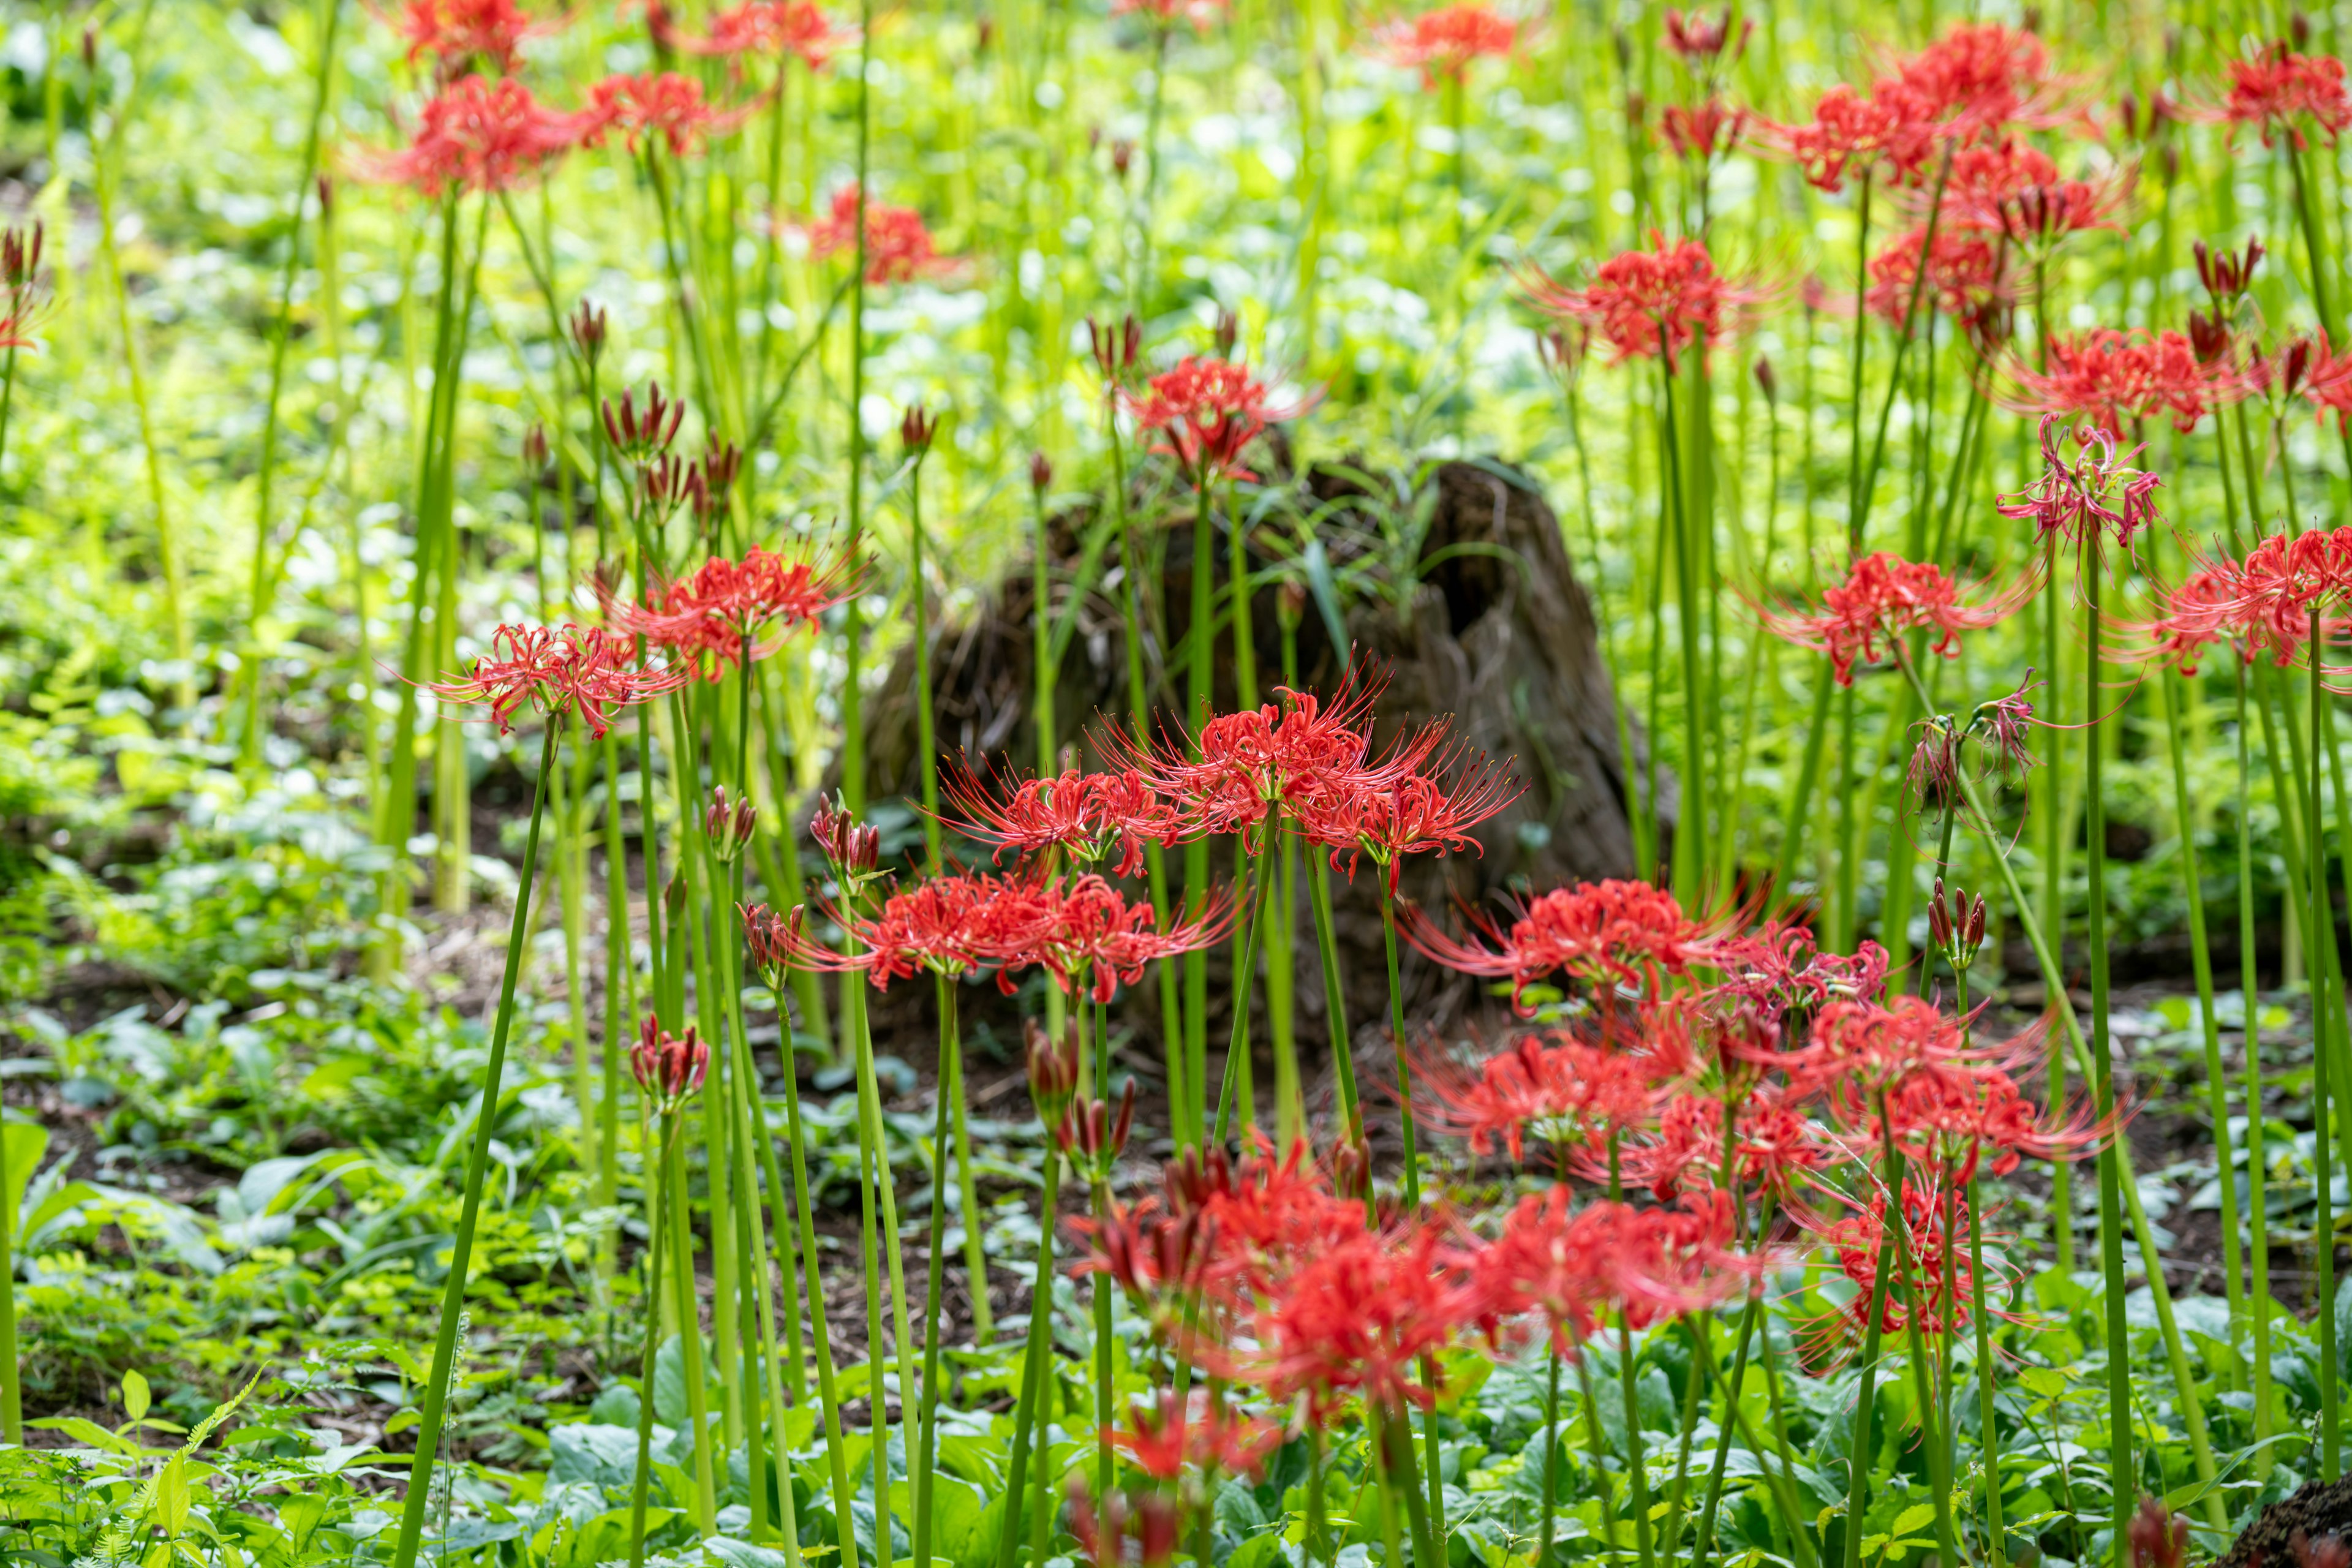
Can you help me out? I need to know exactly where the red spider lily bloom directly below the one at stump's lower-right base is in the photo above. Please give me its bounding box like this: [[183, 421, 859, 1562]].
[[1416, 1032, 1658, 1164]]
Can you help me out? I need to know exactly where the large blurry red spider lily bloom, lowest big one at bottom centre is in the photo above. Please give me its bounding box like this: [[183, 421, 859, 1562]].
[[1232, 1225, 1475, 1420]]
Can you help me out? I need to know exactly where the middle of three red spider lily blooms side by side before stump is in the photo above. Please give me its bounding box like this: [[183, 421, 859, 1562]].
[[1103, 670, 1411, 853]]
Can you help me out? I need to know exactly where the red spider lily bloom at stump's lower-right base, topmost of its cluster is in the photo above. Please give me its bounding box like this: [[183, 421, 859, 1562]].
[[1404, 879, 1724, 1013]]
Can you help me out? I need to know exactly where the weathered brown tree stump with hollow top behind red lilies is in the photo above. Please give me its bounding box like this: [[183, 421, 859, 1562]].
[[846, 463, 1675, 1133]]
